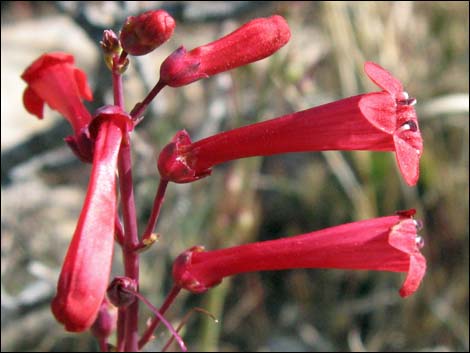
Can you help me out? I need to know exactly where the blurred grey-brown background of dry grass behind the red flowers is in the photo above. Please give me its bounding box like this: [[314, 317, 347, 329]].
[[1, 1, 469, 352]]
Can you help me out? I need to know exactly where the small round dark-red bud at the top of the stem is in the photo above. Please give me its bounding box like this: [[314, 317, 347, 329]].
[[119, 10, 175, 55]]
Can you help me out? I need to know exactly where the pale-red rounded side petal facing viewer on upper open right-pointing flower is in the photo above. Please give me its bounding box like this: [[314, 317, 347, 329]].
[[359, 92, 397, 134]]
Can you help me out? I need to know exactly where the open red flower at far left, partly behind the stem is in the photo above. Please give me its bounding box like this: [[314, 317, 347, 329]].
[[21, 52, 93, 161]]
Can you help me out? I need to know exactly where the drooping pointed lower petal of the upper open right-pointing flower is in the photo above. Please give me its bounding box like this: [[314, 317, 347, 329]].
[[393, 132, 422, 186]]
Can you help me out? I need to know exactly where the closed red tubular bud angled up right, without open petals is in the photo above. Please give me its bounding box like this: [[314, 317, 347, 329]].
[[160, 15, 290, 87]]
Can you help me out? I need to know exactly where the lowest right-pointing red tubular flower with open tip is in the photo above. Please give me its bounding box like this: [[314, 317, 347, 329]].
[[173, 210, 426, 297]]
